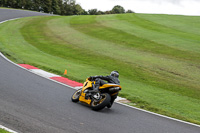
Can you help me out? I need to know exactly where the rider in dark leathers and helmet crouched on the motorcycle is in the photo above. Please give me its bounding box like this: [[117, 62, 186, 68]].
[[89, 71, 120, 92]]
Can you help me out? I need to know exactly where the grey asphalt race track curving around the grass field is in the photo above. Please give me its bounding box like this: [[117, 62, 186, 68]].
[[0, 9, 200, 133]]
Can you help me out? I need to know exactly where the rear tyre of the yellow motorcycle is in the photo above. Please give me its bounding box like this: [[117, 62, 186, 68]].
[[91, 93, 111, 111]]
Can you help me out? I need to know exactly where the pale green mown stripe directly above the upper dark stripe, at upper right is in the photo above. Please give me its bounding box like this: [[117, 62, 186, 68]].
[[97, 15, 200, 54]]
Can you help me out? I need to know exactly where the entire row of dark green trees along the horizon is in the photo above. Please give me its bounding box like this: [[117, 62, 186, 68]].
[[0, 0, 133, 15]]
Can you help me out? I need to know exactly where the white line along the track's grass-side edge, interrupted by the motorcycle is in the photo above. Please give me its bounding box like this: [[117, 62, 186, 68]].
[[0, 19, 200, 132]]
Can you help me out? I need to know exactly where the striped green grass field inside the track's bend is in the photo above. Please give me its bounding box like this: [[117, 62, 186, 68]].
[[0, 14, 200, 124]]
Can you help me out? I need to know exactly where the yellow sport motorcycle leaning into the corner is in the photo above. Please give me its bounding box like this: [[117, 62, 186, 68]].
[[71, 78, 122, 111]]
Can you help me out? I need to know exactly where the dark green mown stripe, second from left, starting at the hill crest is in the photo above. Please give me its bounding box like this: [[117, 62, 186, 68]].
[[70, 16, 200, 61]]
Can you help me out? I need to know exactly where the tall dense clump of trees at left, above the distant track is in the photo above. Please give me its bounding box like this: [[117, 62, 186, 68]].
[[0, 0, 85, 15]]
